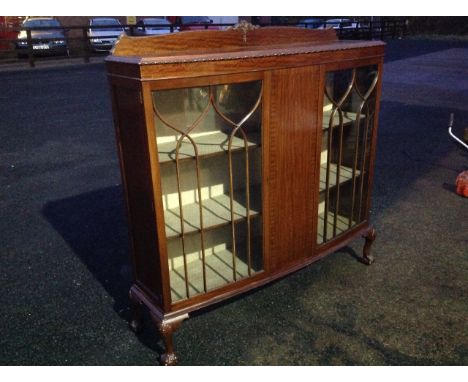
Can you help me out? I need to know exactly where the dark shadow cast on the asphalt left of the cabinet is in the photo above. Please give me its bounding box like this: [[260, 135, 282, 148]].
[[42, 186, 168, 362]]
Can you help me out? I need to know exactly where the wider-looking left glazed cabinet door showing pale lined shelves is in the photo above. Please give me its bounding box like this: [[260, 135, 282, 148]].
[[151, 75, 263, 304]]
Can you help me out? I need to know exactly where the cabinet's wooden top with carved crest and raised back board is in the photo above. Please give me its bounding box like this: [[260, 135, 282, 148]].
[[106, 24, 385, 79]]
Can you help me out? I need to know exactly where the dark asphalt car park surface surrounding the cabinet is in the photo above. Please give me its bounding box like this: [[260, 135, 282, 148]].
[[0, 40, 468, 365]]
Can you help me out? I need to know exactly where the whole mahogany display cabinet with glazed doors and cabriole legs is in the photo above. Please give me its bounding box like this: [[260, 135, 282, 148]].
[[106, 23, 384, 364]]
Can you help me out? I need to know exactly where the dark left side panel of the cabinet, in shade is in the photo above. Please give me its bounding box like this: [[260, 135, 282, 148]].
[[113, 86, 162, 300]]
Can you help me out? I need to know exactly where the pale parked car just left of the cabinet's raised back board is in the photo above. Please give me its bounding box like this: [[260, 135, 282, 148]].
[[87, 17, 125, 52]]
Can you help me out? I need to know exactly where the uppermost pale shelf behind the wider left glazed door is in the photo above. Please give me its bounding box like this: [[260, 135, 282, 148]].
[[158, 131, 260, 163]]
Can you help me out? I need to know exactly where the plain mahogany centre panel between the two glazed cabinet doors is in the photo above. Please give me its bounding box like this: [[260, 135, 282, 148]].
[[266, 67, 319, 272]]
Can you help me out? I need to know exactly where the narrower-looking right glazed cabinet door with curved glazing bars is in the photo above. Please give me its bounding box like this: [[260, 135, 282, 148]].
[[317, 64, 380, 245]]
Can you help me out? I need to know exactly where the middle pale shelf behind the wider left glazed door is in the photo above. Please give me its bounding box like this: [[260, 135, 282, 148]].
[[164, 190, 261, 239]]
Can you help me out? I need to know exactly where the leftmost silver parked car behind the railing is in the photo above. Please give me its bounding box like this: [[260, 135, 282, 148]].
[[16, 17, 68, 57]]
